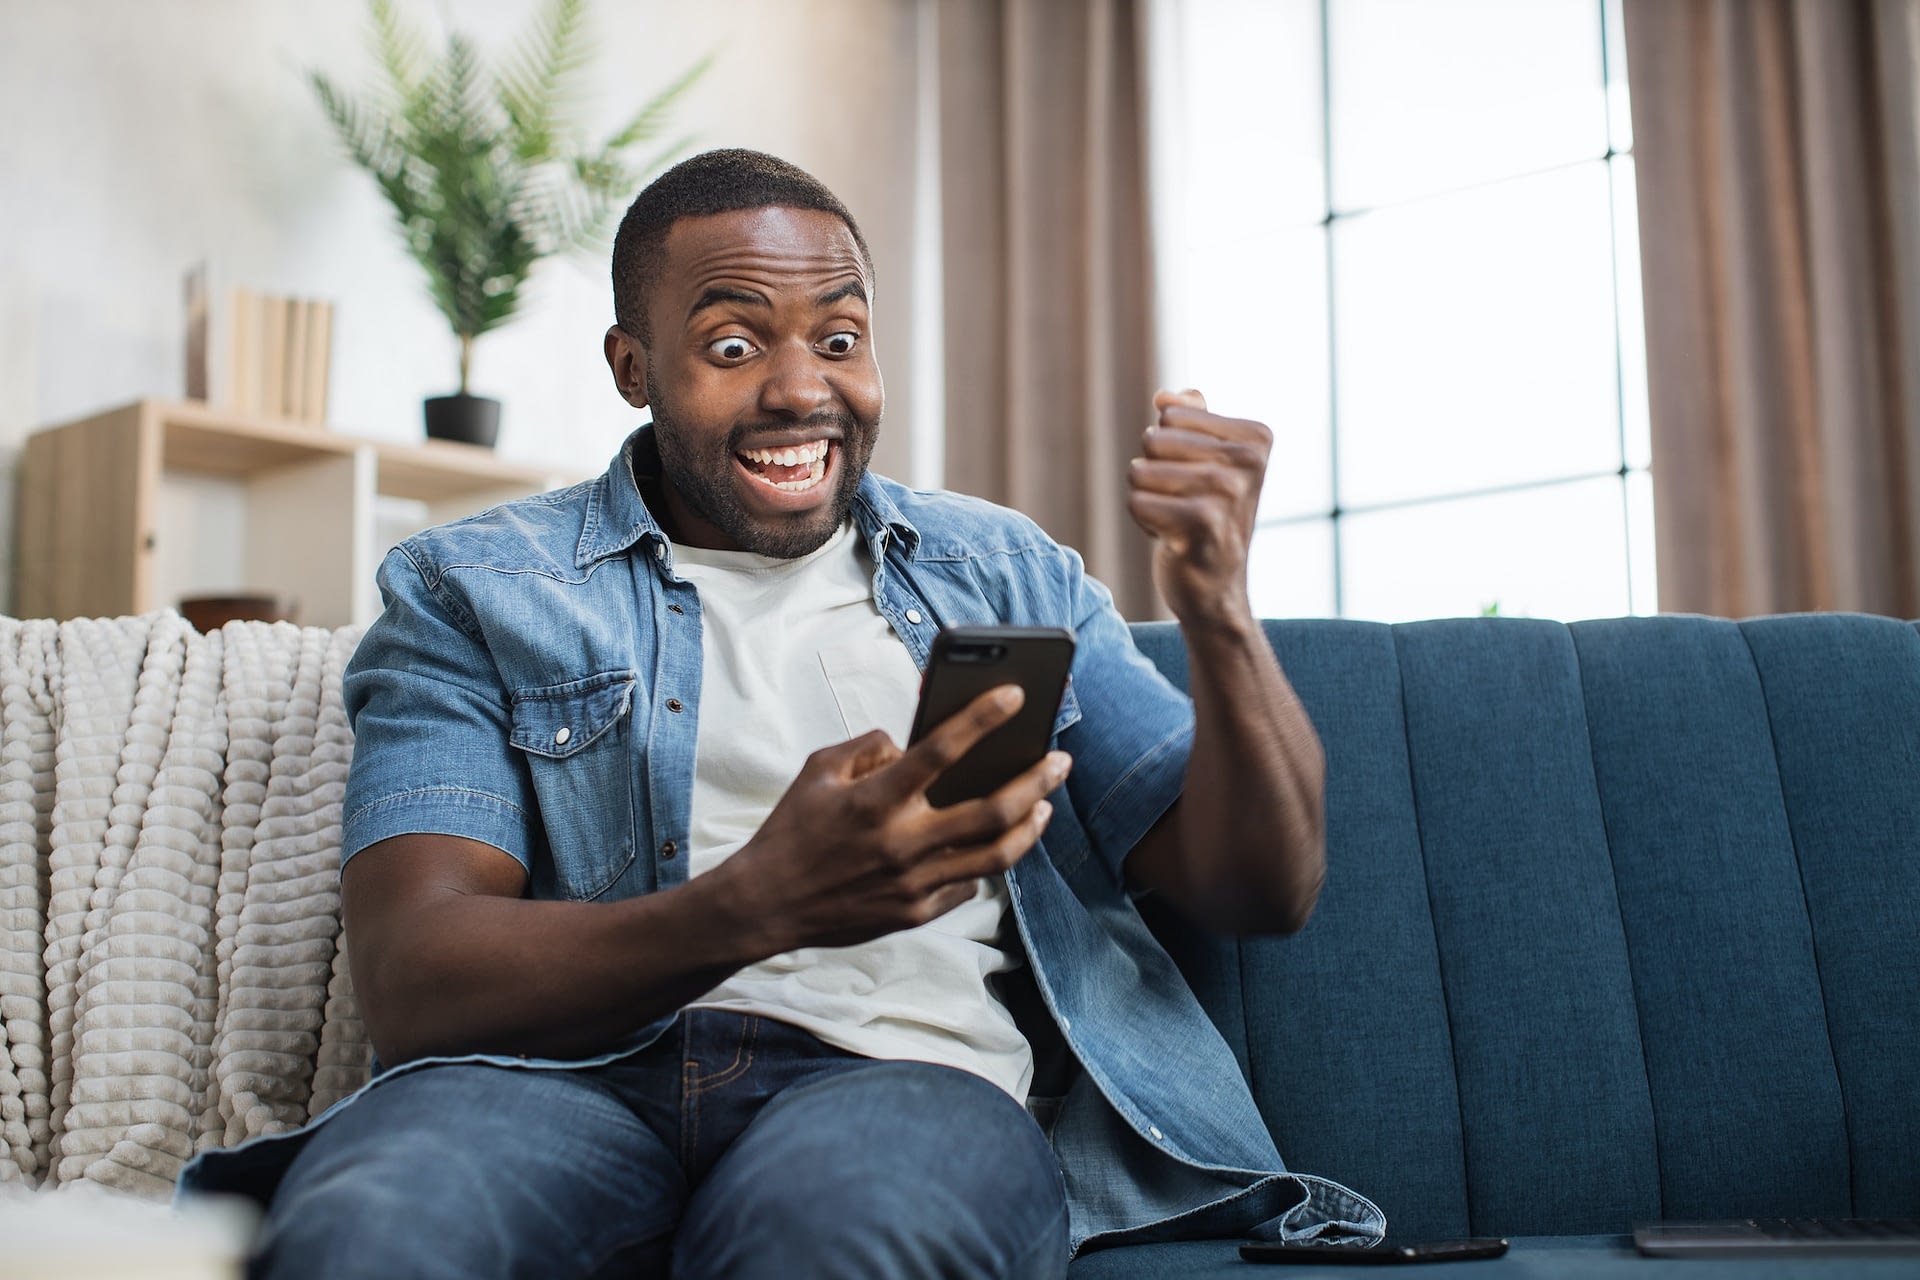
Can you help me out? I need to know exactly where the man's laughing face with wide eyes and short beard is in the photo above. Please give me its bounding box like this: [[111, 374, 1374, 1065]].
[[622, 197, 885, 558]]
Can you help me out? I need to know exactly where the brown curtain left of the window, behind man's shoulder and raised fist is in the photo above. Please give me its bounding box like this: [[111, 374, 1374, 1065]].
[[937, 0, 1160, 618]]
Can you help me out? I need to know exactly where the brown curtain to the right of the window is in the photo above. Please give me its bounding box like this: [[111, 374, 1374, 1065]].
[[1624, 0, 1920, 618]]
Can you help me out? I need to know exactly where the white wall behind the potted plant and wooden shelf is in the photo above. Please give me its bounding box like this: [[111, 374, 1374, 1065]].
[[0, 0, 916, 604]]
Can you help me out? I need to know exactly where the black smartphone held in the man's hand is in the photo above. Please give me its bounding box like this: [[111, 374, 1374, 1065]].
[[906, 626, 1073, 808]]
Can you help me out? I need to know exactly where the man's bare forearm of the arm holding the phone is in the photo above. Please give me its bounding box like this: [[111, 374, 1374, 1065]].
[[348, 859, 776, 1065]]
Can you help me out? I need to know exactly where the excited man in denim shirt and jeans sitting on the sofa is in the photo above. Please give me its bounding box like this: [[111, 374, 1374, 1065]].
[[186, 152, 1379, 1276]]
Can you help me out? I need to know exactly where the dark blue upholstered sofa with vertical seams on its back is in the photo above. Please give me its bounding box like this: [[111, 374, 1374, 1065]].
[[1071, 614, 1920, 1280]]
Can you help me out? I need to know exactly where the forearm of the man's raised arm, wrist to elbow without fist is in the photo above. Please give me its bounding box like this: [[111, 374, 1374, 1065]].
[[1177, 612, 1327, 933]]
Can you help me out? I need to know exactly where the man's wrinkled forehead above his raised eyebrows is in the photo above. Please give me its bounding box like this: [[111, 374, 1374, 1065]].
[[660, 207, 872, 311]]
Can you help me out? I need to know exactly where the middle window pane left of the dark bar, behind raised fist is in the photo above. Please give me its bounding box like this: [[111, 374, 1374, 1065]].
[[1167, 226, 1332, 520]]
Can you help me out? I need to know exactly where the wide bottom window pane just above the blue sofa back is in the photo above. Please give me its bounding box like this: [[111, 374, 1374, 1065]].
[[1340, 476, 1630, 622]]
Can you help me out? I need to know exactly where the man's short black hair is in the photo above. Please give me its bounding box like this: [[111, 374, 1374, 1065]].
[[612, 148, 874, 344]]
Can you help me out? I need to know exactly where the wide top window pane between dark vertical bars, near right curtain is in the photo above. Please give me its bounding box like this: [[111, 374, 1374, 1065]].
[[1329, 0, 1607, 209]]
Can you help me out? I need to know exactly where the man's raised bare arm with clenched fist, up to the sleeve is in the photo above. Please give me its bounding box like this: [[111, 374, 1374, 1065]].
[[1127, 391, 1327, 933]]
